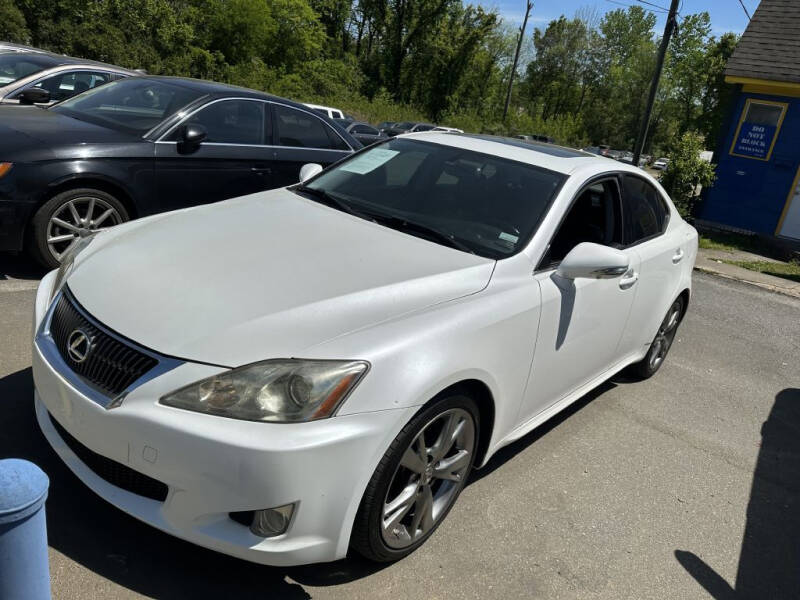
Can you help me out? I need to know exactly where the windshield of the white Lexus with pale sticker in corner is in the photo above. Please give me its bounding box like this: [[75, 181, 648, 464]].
[[298, 138, 566, 259]]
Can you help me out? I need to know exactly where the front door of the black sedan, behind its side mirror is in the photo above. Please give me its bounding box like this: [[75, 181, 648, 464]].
[[155, 98, 274, 210]]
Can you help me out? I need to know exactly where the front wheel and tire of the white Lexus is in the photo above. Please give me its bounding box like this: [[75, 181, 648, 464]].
[[350, 394, 479, 562]]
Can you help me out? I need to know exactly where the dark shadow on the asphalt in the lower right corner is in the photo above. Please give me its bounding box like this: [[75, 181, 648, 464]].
[[675, 388, 800, 600]]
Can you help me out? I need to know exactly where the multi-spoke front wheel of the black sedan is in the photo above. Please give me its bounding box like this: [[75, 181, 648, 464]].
[[30, 188, 130, 269]]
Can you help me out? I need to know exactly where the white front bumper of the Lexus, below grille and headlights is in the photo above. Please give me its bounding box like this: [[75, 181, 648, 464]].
[[33, 276, 414, 566]]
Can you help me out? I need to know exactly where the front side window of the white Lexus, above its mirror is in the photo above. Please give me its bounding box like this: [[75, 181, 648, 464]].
[[539, 179, 622, 268]]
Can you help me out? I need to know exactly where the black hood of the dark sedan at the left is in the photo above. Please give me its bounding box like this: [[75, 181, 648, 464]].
[[0, 105, 131, 150]]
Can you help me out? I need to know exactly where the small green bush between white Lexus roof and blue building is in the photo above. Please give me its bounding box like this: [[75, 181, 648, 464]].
[[661, 131, 716, 217]]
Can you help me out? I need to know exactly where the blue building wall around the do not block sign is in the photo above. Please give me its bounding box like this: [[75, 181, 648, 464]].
[[698, 92, 800, 235]]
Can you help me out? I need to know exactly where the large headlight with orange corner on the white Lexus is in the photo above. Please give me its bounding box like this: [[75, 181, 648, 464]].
[[160, 359, 368, 423]]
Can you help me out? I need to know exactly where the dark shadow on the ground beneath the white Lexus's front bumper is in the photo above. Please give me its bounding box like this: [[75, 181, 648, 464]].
[[0, 368, 384, 600]]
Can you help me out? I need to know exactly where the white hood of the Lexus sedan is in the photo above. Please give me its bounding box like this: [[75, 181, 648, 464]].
[[68, 189, 495, 366]]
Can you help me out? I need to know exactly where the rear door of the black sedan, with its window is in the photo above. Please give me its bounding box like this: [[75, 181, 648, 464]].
[[272, 103, 353, 187]]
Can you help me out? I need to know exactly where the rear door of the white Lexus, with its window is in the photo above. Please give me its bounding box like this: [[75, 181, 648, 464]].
[[620, 173, 690, 353]]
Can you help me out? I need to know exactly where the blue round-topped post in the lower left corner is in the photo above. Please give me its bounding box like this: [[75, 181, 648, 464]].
[[0, 458, 50, 600]]
